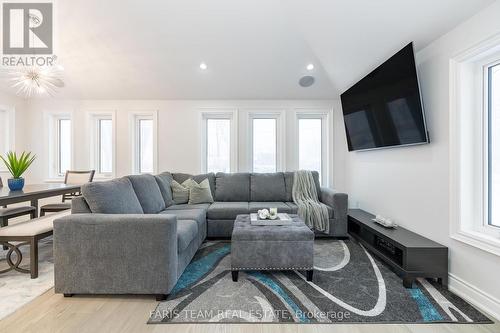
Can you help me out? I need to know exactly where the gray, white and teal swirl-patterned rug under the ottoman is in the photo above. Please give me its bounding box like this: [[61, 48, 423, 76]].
[[148, 240, 492, 324]]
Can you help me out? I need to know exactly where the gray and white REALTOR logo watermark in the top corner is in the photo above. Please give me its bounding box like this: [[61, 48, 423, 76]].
[[2, 2, 55, 66]]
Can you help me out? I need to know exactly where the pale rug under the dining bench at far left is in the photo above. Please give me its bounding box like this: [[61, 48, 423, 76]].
[[0, 237, 54, 320]]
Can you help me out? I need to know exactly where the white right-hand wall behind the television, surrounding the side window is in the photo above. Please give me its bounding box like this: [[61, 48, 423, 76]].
[[344, 1, 500, 318]]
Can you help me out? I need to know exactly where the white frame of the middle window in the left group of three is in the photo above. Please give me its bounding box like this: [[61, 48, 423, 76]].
[[88, 110, 116, 179]]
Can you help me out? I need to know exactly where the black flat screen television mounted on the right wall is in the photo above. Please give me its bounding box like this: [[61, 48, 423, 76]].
[[340, 43, 429, 151]]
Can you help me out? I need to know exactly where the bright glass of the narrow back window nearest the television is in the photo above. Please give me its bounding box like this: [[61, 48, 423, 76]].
[[299, 118, 323, 179]]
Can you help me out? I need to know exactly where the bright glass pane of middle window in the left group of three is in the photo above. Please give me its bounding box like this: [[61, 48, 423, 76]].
[[97, 119, 113, 174]]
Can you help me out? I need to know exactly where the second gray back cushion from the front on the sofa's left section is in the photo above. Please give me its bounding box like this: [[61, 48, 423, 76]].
[[127, 175, 166, 214]]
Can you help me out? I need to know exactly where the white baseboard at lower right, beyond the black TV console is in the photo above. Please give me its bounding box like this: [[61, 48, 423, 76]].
[[448, 273, 500, 320]]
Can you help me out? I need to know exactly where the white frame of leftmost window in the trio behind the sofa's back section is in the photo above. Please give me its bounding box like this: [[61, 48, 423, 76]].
[[200, 108, 238, 173]]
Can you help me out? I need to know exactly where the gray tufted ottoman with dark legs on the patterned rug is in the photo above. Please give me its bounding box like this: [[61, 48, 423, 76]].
[[231, 215, 314, 281]]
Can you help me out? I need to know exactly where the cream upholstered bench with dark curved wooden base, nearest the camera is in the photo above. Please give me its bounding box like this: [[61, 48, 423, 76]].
[[0, 211, 70, 279]]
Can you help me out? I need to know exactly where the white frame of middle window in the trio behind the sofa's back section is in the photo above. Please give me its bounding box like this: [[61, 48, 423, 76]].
[[247, 109, 286, 172]]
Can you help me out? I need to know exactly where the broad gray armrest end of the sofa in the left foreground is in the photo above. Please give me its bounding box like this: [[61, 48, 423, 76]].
[[54, 214, 178, 294]]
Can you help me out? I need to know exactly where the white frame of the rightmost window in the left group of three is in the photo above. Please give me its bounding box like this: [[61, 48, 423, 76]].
[[129, 110, 158, 174]]
